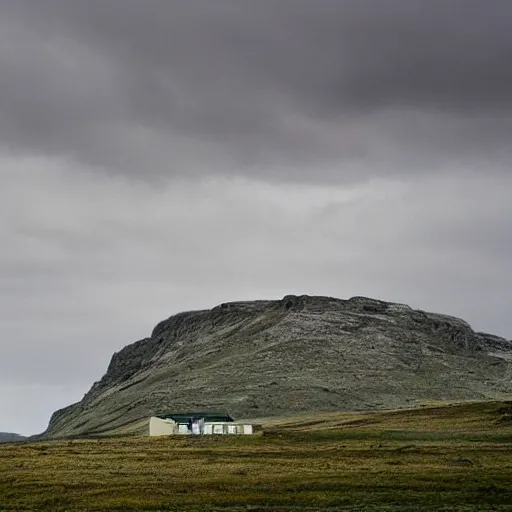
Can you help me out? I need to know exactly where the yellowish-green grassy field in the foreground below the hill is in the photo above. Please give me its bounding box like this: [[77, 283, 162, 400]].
[[0, 402, 512, 512]]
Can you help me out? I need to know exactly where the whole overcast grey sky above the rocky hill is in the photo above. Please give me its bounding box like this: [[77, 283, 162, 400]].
[[0, 0, 512, 434]]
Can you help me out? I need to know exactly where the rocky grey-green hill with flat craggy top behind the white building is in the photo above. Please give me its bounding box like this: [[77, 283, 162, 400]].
[[44, 296, 512, 437]]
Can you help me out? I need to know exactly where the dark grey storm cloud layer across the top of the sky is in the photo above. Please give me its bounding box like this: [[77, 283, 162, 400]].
[[0, 0, 512, 179]]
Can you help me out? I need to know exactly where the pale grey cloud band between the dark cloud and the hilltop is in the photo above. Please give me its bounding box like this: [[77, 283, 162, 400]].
[[0, 161, 512, 385]]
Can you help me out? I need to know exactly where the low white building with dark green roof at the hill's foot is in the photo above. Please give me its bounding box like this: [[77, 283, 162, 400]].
[[149, 412, 254, 436]]
